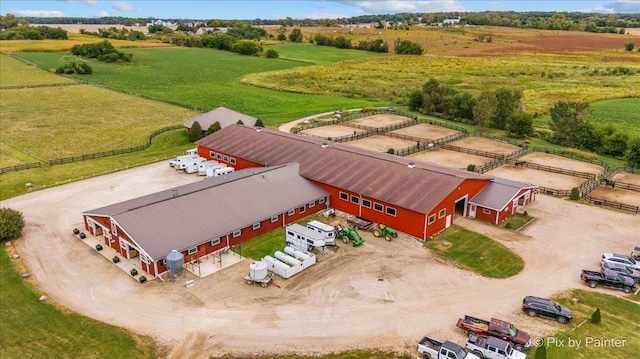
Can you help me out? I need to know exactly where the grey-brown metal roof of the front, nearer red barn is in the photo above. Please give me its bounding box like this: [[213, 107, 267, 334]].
[[84, 163, 329, 260]]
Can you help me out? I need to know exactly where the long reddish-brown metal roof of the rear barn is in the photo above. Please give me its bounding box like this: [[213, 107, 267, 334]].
[[196, 125, 490, 213]]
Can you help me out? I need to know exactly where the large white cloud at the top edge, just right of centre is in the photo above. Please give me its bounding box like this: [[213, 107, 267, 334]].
[[337, 0, 465, 14]]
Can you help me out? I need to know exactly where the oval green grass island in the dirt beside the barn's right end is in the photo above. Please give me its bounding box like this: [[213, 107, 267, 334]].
[[425, 225, 524, 278]]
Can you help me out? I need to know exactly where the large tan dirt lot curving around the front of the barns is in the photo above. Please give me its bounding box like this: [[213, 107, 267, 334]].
[[3, 163, 640, 359]]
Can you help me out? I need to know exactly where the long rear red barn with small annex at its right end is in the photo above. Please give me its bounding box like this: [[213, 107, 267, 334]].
[[196, 125, 536, 240]]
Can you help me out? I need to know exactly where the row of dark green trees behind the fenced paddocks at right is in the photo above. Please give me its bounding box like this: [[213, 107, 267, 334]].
[[408, 78, 640, 167]]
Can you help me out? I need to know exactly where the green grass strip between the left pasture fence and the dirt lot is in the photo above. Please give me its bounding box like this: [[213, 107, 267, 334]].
[[0, 129, 194, 200]]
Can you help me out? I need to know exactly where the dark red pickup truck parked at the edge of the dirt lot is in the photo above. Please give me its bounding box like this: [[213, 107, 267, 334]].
[[456, 315, 531, 351]]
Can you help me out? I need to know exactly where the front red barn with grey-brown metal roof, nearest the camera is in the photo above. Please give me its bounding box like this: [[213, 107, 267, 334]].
[[83, 163, 329, 276]]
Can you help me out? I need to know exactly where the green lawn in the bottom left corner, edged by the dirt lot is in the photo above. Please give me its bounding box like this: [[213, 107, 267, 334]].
[[0, 248, 158, 359]]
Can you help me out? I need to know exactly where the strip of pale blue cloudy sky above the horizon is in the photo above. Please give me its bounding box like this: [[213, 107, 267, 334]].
[[0, 0, 640, 20]]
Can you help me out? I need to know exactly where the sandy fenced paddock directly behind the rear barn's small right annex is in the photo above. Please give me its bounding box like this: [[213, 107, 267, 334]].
[[486, 163, 587, 190]]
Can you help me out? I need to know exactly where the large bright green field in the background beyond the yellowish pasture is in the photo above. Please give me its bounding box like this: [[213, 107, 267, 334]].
[[18, 47, 388, 127]]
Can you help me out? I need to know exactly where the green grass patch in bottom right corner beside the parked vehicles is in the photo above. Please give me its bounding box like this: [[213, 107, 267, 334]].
[[529, 290, 640, 359]]
